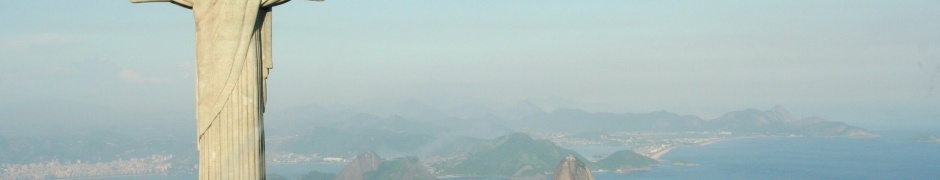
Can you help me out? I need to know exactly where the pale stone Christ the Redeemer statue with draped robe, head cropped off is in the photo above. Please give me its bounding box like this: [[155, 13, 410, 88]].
[[130, 0, 316, 179]]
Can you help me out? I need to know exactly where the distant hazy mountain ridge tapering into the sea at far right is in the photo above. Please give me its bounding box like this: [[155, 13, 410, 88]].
[[513, 106, 878, 138]]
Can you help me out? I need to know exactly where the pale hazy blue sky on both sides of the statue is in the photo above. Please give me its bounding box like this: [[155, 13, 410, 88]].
[[0, 0, 940, 126]]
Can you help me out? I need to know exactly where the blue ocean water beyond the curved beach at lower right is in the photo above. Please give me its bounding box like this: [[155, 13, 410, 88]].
[[594, 134, 940, 179]]
